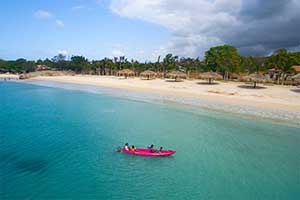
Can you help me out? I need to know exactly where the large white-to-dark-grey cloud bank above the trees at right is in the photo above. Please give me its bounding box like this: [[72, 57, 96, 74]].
[[110, 0, 300, 57]]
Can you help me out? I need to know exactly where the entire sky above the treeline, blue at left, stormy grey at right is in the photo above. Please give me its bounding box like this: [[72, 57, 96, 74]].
[[0, 0, 300, 61]]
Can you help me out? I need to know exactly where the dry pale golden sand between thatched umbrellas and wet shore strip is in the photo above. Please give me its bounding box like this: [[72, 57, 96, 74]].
[[30, 75, 300, 112]]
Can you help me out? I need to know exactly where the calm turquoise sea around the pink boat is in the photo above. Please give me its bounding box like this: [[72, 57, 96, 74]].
[[0, 82, 300, 200]]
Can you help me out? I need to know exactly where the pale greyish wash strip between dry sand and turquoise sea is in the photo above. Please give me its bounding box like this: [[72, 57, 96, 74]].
[[24, 80, 300, 124]]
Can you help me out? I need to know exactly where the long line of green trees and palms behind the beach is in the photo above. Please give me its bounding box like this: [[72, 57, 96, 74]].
[[0, 45, 300, 78]]
